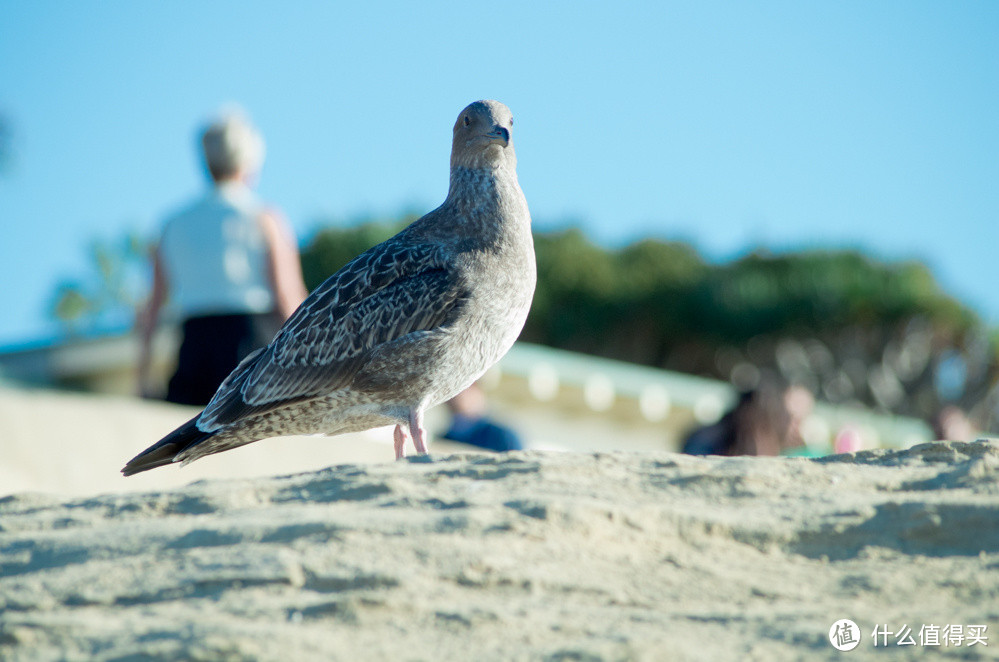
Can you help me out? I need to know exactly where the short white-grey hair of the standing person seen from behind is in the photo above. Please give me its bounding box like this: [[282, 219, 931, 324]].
[[201, 109, 265, 180]]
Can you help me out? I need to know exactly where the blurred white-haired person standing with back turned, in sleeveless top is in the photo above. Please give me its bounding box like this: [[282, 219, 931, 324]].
[[136, 112, 307, 406]]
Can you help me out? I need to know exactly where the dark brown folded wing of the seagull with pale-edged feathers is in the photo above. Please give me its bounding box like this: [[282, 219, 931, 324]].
[[197, 240, 467, 432]]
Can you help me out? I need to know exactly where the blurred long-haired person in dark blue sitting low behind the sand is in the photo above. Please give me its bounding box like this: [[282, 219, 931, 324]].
[[682, 385, 813, 456]]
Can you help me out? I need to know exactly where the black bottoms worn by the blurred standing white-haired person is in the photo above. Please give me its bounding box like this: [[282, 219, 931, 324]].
[[166, 314, 278, 407]]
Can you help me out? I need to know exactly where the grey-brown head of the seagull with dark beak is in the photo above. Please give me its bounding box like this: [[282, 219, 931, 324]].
[[451, 101, 517, 168]]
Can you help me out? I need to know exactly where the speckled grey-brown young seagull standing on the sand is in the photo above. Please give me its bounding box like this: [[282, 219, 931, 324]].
[[121, 101, 537, 476]]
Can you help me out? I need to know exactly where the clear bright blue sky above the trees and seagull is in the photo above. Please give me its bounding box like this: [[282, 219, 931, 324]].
[[0, 0, 999, 344]]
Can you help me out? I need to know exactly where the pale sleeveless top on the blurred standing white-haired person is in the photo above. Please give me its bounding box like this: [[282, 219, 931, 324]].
[[159, 182, 274, 318]]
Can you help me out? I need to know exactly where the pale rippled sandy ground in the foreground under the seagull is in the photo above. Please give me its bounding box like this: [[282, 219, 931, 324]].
[[0, 386, 999, 661]]
